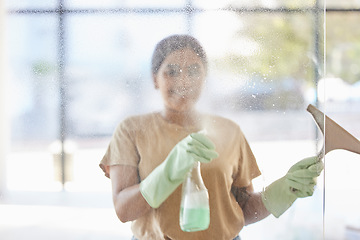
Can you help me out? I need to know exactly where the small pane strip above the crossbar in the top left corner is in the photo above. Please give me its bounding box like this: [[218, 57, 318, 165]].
[[5, 0, 58, 10]]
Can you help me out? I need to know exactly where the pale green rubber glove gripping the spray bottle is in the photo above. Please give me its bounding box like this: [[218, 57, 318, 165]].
[[140, 133, 219, 208]]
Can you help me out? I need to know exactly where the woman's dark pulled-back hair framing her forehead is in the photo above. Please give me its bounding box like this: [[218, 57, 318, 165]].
[[151, 35, 207, 74]]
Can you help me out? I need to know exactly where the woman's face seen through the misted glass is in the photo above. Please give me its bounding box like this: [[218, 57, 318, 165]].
[[154, 48, 206, 112]]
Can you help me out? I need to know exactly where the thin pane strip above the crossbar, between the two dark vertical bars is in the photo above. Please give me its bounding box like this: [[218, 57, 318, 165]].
[[65, 0, 186, 8]]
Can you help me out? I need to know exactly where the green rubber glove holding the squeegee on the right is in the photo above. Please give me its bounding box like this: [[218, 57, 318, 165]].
[[262, 156, 324, 218]]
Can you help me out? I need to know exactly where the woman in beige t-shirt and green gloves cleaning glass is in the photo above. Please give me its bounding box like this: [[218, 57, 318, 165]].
[[100, 35, 322, 240]]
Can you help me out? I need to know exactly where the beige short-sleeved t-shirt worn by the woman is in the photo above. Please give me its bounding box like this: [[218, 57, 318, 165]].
[[100, 113, 260, 240]]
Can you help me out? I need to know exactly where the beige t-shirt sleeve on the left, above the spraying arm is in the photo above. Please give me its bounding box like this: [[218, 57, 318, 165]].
[[99, 120, 139, 177]]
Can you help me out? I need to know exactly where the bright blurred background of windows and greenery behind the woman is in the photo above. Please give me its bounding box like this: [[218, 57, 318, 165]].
[[0, 0, 360, 240]]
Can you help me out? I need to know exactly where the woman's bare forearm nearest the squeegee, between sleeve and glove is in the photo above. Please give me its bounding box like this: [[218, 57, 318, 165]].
[[231, 185, 270, 225]]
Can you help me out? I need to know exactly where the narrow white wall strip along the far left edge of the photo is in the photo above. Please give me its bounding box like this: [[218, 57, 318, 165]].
[[0, 1, 10, 194]]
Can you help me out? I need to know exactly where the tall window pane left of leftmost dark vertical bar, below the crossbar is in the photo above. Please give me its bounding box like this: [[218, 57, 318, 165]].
[[6, 15, 59, 189]]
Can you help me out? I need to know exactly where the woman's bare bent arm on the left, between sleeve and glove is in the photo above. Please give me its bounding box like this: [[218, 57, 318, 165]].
[[110, 165, 151, 222]]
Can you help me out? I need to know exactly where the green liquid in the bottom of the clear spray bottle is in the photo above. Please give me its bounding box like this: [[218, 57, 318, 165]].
[[180, 207, 210, 232]]
